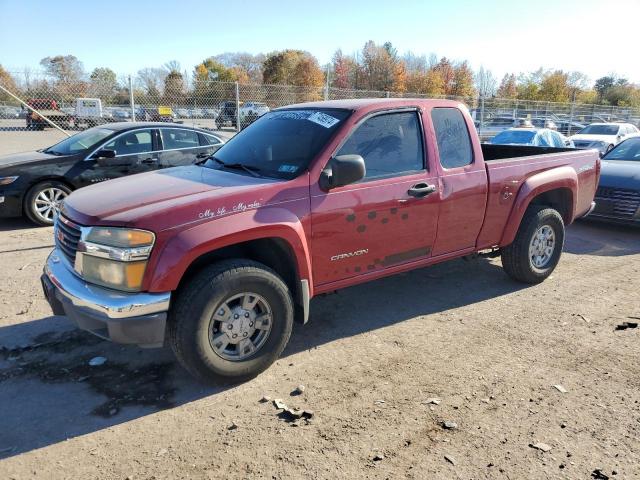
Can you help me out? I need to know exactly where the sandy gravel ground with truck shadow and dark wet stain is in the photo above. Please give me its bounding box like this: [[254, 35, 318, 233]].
[[0, 216, 640, 479]]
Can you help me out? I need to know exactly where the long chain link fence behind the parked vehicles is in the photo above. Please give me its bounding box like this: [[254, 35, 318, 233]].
[[0, 72, 640, 140]]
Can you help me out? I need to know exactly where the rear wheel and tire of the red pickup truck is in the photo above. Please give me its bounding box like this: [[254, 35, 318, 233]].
[[501, 205, 564, 284]]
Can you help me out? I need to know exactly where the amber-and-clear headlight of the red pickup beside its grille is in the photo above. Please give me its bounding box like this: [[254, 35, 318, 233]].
[[75, 227, 155, 292]]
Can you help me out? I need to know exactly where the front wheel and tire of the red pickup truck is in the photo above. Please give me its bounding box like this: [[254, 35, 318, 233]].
[[168, 259, 294, 384]]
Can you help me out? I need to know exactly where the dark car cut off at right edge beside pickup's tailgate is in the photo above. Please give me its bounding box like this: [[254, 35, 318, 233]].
[[589, 137, 640, 226]]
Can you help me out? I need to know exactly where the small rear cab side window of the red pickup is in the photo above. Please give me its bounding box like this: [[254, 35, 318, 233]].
[[431, 107, 473, 169]]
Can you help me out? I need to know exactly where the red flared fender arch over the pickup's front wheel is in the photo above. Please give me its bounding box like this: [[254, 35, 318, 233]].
[[146, 206, 313, 292]]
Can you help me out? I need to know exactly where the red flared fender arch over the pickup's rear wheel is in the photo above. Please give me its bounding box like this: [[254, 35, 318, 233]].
[[500, 166, 578, 247]]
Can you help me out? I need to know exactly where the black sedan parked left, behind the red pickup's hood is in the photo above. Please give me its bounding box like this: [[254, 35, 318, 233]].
[[0, 122, 224, 225]]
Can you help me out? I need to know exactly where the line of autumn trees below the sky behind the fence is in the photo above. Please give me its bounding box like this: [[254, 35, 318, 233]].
[[0, 41, 640, 107]]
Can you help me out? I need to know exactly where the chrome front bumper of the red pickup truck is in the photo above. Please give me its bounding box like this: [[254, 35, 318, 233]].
[[41, 249, 171, 347]]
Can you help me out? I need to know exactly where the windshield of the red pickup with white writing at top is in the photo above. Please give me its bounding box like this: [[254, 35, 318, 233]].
[[204, 109, 351, 180]]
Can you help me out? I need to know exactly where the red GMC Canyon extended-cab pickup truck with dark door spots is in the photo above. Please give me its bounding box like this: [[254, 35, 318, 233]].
[[42, 99, 600, 381]]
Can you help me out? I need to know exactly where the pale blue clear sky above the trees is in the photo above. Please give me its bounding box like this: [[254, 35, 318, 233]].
[[0, 0, 640, 83]]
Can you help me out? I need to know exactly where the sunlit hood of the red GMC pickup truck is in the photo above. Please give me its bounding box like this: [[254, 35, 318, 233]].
[[62, 165, 309, 232]]
